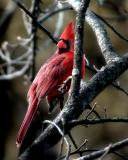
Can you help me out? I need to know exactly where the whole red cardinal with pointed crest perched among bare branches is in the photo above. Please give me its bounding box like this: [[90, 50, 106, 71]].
[[16, 23, 85, 146]]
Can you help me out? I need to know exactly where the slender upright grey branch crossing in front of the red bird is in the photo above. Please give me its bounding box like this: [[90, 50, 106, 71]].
[[68, 0, 90, 112]]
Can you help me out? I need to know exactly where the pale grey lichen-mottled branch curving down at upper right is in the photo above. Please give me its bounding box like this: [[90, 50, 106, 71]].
[[68, 0, 119, 63]]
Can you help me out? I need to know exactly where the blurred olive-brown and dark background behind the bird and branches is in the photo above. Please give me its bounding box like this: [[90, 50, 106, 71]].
[[0, 0, 128, 160]]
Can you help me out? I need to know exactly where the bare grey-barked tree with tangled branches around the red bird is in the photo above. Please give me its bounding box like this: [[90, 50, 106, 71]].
[[0, 0, 128, 160]]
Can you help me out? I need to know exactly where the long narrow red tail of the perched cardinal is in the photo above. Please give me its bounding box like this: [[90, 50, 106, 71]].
[[16, 98, 39, 147]]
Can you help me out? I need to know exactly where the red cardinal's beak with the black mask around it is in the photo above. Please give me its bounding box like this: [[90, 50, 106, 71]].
[[57, 39, 70, 52]]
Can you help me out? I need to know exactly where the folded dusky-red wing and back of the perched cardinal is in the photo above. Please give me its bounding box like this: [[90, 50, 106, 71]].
[[28, 53, 73, 101]]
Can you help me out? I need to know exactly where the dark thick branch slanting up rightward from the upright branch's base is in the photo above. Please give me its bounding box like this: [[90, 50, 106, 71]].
[[81, 55, 128, 106]]
